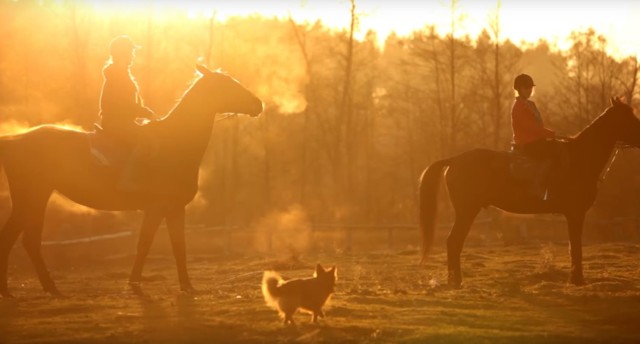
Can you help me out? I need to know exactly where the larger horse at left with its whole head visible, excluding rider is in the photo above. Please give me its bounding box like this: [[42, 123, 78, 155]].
[[0, 66, 263, 297]]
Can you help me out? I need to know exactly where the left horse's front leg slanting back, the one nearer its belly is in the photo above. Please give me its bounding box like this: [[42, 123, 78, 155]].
[[129, 210, 164, 293]]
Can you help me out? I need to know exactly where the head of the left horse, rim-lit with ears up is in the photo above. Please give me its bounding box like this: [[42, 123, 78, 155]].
[[196, 65, 263, 117]]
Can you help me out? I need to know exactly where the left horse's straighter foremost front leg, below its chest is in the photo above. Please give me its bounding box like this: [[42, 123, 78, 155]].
[[167, 207, 195, 293]]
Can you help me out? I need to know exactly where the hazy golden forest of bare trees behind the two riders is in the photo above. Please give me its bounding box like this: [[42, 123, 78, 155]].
[[0, 1, 640, 242]]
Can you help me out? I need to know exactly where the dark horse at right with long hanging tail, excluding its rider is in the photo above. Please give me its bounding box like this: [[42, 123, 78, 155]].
[[420, 98, 640, 286]]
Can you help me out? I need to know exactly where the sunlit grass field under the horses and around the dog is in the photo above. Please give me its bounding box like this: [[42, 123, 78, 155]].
[[0, 239, 640, 344]]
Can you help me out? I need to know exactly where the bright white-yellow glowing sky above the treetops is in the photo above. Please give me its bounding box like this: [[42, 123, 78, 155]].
[[79, 0, 640, 57]]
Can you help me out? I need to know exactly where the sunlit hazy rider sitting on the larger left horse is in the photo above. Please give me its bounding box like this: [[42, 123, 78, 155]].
[[100, 36, 154, 189]]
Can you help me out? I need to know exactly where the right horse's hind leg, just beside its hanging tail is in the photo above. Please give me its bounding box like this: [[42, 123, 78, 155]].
[[447, 207, 480, 287]]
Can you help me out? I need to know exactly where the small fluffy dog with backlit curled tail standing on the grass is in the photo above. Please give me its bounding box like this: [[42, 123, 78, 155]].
[[262, 264, 337, 325]]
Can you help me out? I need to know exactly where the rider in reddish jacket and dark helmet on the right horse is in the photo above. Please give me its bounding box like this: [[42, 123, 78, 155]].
[[511, 74, 569, 199]]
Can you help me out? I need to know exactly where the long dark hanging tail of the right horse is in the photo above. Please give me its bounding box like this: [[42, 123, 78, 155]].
[[419, 159, 451, 264]]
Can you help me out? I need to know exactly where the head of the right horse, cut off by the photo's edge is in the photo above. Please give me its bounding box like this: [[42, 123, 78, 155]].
[[605, 97, 640, 147]]
